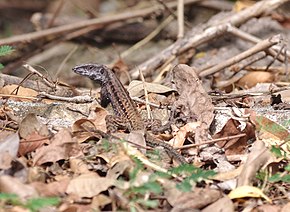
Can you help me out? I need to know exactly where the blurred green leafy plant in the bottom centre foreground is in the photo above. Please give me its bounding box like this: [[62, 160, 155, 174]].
[[120, 158, 215, 211]]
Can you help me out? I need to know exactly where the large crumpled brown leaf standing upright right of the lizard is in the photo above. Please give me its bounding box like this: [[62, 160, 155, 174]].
[[172, 64, 214, 143]]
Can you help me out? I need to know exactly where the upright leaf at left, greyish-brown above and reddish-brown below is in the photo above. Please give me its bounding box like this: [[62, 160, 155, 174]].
[[18, 113, 49, 155]]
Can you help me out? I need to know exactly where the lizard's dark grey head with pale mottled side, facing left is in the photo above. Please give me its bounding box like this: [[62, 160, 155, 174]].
[[72, 63, 108, 84]]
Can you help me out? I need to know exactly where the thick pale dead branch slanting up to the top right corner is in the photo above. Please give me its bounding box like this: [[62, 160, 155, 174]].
[[132, 0, 288, 79]]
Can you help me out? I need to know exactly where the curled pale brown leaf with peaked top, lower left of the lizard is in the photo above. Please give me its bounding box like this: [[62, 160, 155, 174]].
[[33, 129, 81, 165]]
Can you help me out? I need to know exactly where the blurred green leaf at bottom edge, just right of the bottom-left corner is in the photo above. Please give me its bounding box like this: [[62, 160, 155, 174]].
[[25, 197, 60, 211]]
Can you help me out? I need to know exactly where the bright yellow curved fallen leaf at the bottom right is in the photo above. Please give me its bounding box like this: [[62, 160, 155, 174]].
[[228, 185, 272, 203]]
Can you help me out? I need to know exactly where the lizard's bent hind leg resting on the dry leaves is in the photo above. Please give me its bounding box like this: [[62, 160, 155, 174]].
[[105, 115, 130, 133]]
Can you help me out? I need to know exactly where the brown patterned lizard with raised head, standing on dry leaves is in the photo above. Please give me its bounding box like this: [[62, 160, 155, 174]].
[[72, 63, 187, 164]]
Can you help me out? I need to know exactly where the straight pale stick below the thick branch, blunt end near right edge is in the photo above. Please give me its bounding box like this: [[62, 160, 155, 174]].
[[199, 34, 282, 77]]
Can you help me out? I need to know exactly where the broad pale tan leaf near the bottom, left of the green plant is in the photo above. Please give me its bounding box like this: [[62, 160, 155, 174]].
[[66, 173, 115, 197]]
